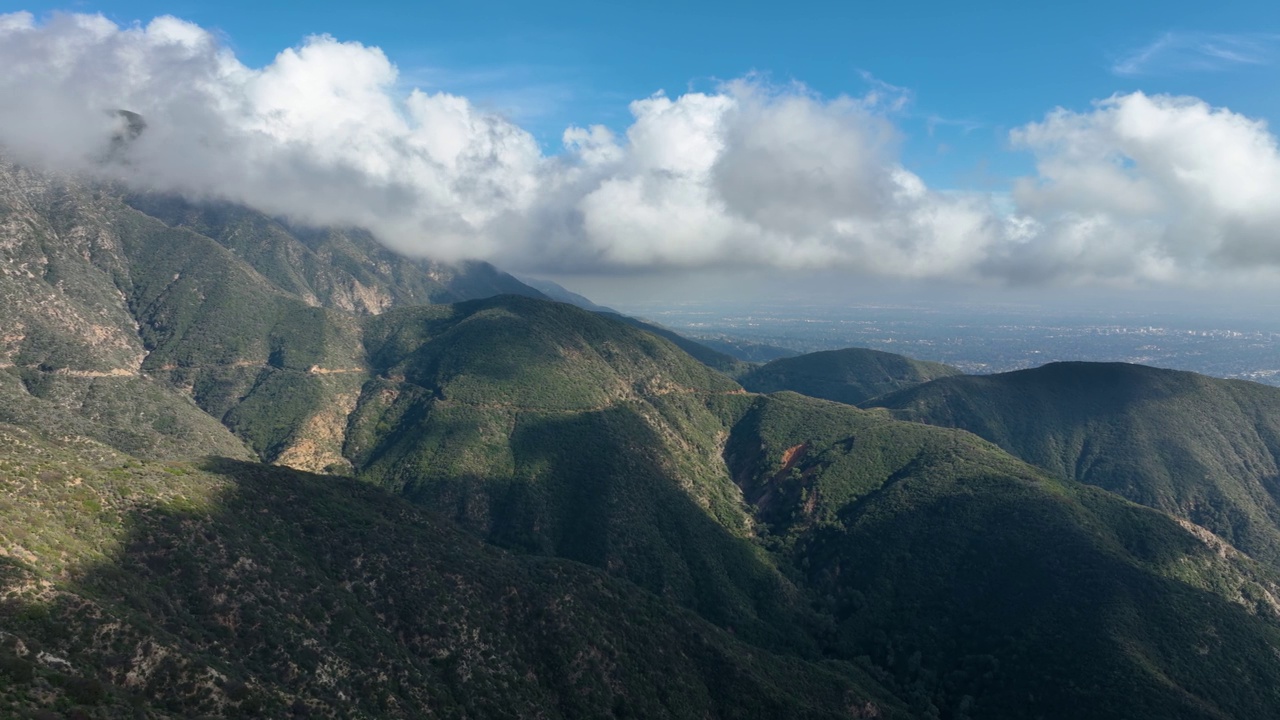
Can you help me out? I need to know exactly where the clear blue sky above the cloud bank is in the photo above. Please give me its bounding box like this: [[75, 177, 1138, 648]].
[[12, 0, 1280, 190]]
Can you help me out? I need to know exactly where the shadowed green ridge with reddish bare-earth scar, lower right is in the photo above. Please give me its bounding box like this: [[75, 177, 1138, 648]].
[[726, 393, 1280, 720]]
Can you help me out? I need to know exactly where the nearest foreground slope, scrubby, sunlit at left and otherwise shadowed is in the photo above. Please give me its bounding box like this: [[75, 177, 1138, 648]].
[[0, 425, 904, 719]]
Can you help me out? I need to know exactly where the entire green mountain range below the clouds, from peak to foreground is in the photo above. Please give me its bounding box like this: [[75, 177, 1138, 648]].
[[0, 160, 1280, 720]]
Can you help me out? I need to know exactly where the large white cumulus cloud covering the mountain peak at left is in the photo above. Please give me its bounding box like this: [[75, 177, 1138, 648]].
[[0, 14, 543, 258]]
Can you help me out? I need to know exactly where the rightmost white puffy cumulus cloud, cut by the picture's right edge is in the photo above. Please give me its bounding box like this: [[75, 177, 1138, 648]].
[[1002, 92, 1280, 281]]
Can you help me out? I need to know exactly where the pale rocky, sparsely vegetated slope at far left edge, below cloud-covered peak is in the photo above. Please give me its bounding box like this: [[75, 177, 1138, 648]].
[[0, 156, 246, 457]]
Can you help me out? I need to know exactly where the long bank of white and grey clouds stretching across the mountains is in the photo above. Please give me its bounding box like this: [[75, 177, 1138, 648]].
[[0, 13, 1280, 284]]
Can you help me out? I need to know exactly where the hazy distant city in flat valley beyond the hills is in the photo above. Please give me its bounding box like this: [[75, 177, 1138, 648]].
[[623, 302, 1280, 386]]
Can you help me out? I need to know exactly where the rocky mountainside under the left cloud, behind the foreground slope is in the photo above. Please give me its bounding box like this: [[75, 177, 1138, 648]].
[[0, 155, 539, 471]]
